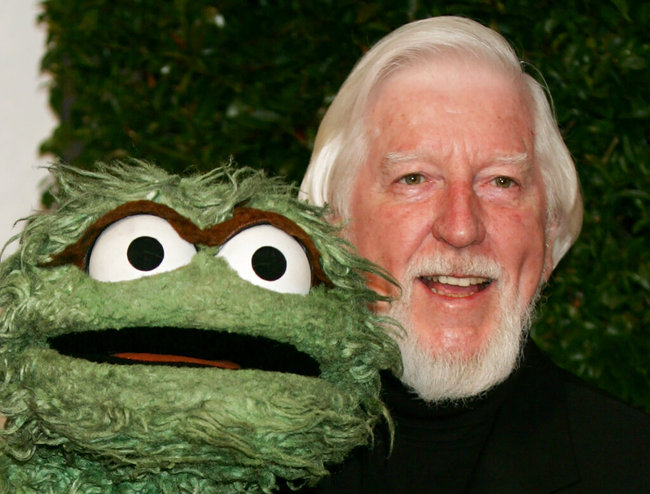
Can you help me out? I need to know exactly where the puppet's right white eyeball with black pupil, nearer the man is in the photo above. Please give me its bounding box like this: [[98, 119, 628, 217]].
[[217, 225, 311, 295]]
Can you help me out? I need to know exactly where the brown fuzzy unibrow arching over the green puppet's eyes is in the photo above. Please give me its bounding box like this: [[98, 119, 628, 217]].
[[44, 201, 331, 286]]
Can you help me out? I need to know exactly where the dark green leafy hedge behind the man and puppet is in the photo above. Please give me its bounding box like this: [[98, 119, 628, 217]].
[[41, 0, 650, 411]]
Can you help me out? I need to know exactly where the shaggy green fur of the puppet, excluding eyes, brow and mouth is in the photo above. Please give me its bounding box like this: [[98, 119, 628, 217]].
[[0, 161, 400, 493]]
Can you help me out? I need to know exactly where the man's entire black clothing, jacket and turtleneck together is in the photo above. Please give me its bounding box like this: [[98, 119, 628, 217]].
[[288, 342, 650, 494]]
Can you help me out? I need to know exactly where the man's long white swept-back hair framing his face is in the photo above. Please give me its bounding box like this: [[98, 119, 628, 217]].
[[300, 16, 582, 267]]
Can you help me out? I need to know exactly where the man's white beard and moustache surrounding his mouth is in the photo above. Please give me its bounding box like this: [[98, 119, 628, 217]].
[[387, 256, 542, 402]]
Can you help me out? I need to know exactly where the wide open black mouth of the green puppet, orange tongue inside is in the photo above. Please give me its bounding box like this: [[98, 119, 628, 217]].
[[48, 327, 320, 377]]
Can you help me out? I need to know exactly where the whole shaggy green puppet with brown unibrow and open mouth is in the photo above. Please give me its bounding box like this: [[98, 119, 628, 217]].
[[0, 161, 400, 493]]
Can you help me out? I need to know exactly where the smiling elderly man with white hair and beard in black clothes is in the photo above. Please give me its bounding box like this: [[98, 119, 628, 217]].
[[301, 17, 650, 493]]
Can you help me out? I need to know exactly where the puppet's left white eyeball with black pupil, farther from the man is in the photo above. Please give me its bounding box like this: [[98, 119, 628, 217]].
[[88, 214, 196, 281]]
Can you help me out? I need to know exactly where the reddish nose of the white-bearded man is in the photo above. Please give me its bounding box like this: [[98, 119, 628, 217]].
[[432, 183, 485, 249]]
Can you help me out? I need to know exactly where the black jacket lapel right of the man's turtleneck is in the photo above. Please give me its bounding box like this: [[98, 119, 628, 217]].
[[466, 340, 580, 494]]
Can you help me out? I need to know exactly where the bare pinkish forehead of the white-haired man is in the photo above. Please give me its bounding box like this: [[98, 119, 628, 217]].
[[365, 59, 534, 149]]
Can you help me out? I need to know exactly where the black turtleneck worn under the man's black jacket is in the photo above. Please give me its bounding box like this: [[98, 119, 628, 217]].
[[307, 352, 515, 494]]
